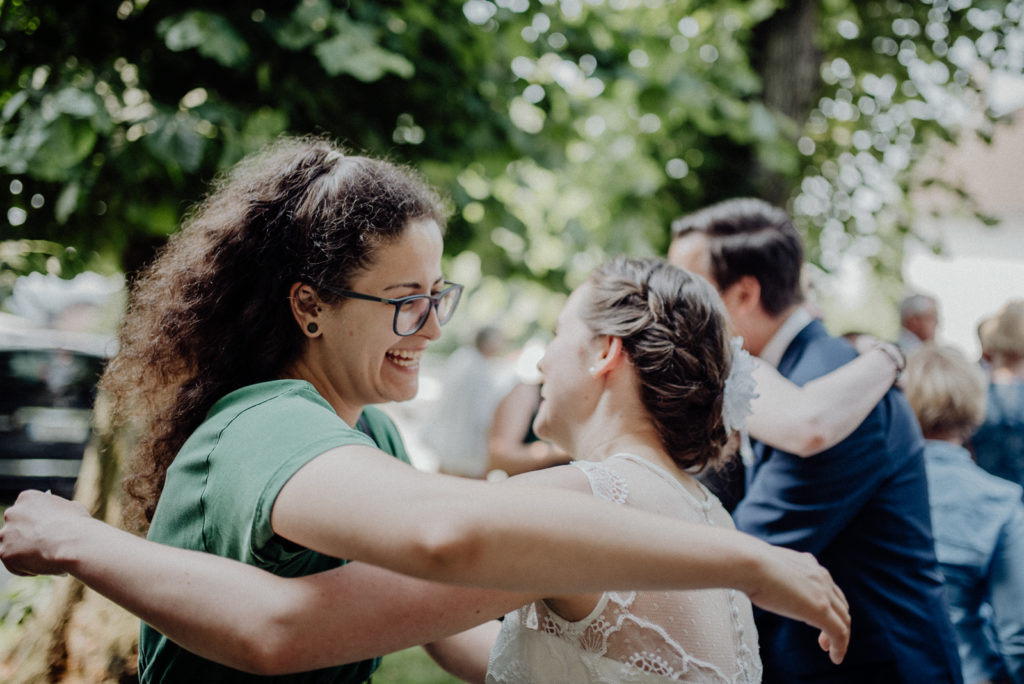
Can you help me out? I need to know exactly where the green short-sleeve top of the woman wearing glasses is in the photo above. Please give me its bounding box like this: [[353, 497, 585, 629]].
[[139, 380, 409, 684]]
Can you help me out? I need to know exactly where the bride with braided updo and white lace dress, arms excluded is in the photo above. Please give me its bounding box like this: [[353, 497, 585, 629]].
[[486, 258, 761, 684]]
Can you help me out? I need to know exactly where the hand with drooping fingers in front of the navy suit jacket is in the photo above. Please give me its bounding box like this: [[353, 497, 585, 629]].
[[746, 545, 850, 665]]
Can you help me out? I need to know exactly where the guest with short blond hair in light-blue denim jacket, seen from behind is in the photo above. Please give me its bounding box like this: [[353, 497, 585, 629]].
[[906, 345, 1024, 684]]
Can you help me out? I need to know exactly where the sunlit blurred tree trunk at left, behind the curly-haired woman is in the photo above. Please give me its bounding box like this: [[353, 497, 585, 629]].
[[0, 400, 138, 684]]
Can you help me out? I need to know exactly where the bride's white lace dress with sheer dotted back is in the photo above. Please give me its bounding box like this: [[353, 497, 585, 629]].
[[486, 454, 761, 684]]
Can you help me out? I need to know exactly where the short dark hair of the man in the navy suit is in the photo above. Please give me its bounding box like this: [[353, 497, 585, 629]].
[[672, 198, 804, 315]]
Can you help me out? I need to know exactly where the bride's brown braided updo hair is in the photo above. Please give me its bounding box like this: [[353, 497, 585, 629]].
[[582, 257, 732, 470]]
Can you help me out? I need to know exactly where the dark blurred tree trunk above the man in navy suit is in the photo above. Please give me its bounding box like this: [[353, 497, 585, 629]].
[[752, 0, 822, 206]]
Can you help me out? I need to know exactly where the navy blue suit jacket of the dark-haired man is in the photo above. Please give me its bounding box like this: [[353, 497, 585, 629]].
[[733, 320, 962, 684]]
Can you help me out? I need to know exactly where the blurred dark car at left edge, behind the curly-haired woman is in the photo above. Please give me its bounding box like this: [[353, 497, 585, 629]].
[[0, 329, 114, 498]]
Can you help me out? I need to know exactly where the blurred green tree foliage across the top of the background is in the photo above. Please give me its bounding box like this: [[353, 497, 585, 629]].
[[0, 0, 1024, 344]]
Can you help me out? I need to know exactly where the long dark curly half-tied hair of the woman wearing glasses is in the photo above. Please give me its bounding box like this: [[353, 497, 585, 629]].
[[100, 137, 447, 521]]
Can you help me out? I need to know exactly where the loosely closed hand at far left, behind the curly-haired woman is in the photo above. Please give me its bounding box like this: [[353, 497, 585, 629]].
[[0, 489, 92, 575]]
